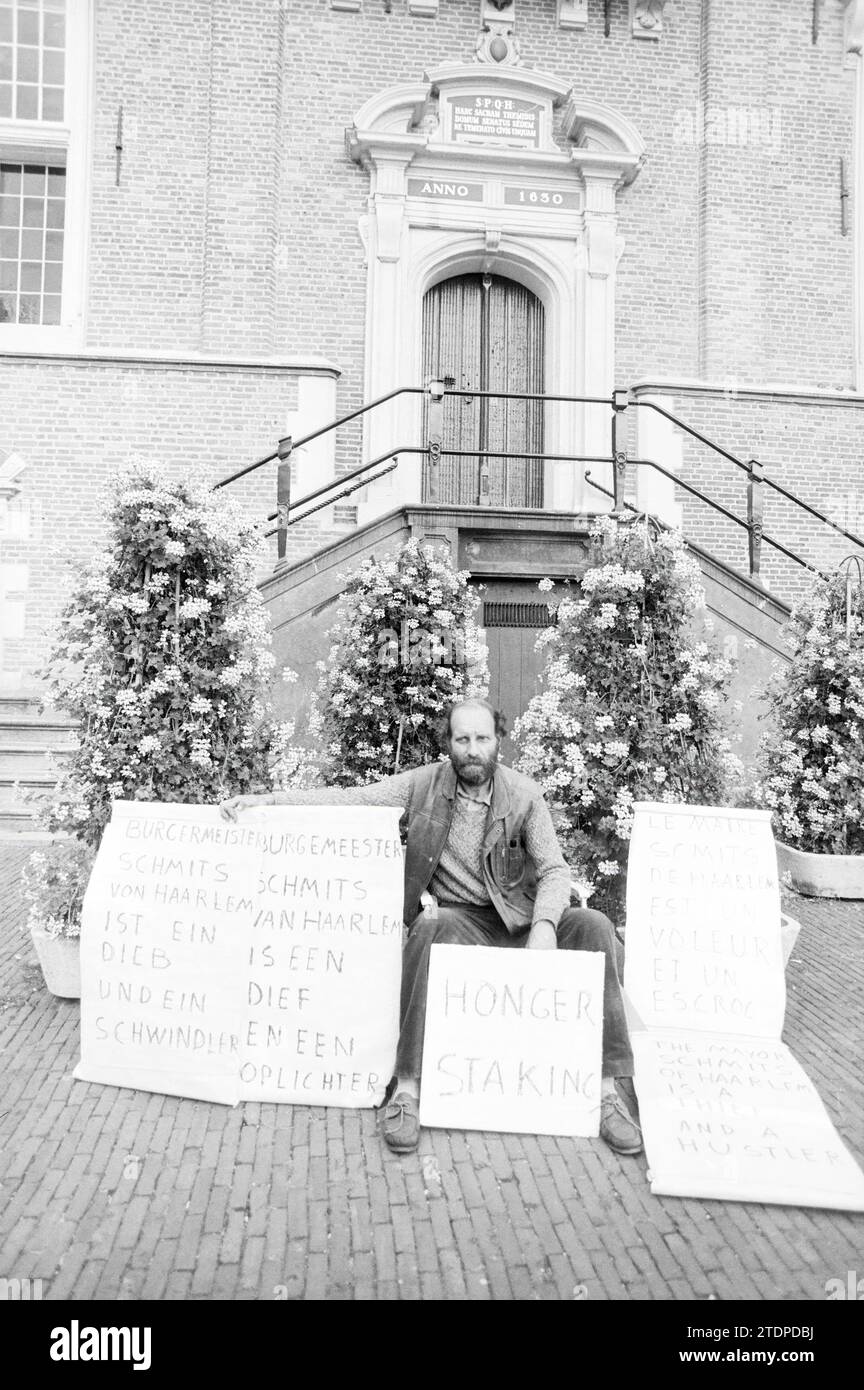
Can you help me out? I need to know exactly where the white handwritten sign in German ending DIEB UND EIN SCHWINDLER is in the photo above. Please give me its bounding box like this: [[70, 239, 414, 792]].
[[75, 802, 253, 1105]]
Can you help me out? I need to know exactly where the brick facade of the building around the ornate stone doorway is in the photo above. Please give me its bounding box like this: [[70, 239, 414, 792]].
[[0, 0, 864, 684]]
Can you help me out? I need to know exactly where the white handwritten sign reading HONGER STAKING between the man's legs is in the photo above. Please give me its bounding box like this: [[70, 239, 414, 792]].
[[419, 945, 604, 1136]]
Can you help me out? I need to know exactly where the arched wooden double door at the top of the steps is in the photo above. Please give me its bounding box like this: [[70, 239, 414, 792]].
[[424, 275, 545, 507]]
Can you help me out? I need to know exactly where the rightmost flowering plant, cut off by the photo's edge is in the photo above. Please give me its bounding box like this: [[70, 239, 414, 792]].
[[756, 574, 864, 855]]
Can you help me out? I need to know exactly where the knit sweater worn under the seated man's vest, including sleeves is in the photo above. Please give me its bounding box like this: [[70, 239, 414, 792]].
[[270, 770, 570, 926]]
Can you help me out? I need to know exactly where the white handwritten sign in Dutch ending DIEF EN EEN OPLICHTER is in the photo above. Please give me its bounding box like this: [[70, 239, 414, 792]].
[[240, 806, 404, 1106]]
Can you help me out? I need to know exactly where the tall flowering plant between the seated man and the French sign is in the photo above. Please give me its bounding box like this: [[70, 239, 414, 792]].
[[514, 517, 731, 915]]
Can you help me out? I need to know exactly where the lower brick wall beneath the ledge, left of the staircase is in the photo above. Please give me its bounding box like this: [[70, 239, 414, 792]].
[[0, 360, 341, 684]]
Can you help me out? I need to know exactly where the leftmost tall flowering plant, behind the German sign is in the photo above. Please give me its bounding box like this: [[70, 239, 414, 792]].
[[34, 464, 272, 845]]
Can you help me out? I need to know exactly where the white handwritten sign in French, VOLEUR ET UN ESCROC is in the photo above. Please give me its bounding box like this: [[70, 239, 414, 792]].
[[625, 802, 786, 1037]]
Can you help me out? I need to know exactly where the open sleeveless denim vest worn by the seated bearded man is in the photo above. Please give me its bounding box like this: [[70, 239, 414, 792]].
[[404, 762, 542, 933]]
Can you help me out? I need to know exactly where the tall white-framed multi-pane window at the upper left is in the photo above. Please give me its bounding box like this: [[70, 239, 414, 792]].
[[0, 0, 92, 352]]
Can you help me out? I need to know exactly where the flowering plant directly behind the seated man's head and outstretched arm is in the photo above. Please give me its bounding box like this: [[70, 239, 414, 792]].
[[274, 541, 489, 787]]
